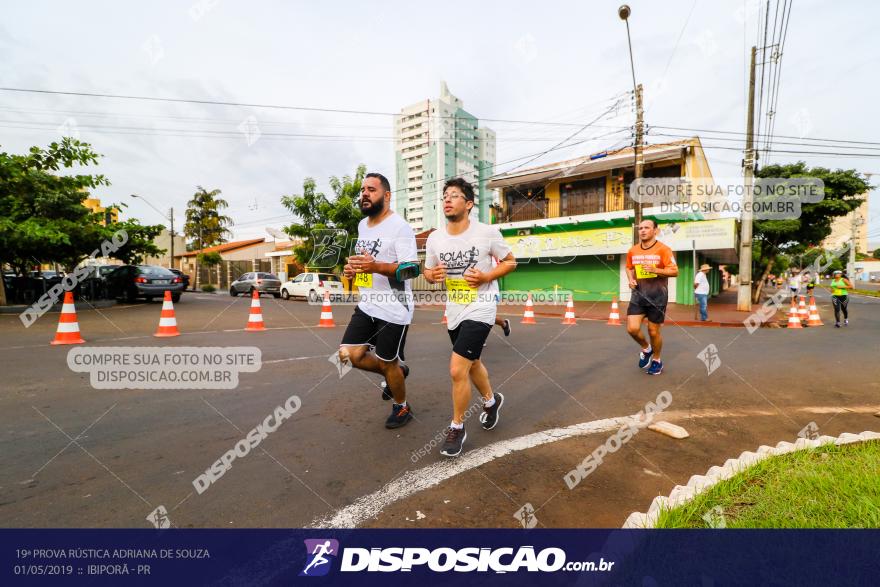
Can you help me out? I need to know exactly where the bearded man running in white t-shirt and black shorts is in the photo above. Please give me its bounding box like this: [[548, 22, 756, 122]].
[[339, 173, 418, 428]]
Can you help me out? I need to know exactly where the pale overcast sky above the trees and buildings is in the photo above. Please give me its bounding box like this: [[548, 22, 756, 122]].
[[0, 0, 880, 246]]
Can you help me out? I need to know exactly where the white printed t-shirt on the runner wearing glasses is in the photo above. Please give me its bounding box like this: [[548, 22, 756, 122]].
[[425, 220, 510, 330]]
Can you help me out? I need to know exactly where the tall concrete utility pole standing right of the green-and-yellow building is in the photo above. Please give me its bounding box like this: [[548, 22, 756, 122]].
[[736, 47, 757, 312]]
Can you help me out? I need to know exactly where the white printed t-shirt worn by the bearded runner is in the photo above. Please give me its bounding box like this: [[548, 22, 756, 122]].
[[352, 213, 419, 324]]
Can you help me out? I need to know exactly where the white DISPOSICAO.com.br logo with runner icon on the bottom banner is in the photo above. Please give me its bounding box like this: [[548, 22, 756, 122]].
[[300, 539, 614, 577]]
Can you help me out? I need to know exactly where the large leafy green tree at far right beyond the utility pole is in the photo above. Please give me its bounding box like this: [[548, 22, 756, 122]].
[[752, 161, 871, 303]]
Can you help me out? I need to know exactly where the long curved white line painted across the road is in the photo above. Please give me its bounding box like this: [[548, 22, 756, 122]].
[[306, 406, 878, 528]]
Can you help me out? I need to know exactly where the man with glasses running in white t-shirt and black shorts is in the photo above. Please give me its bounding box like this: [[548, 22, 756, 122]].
[[425, 178, 516, 457]]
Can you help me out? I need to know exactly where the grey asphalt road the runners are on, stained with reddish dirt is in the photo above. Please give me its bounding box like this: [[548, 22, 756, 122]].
[[0, 292, 880, 527]]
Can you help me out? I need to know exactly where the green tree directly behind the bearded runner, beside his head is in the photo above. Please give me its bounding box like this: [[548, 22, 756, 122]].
[[281, 165, 367, 269]]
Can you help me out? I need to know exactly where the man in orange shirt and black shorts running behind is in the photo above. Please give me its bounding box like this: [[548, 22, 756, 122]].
[[626, 219, 678, 375]]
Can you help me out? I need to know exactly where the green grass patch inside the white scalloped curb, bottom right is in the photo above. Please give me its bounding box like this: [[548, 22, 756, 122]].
[[657, 440, 880, 528]]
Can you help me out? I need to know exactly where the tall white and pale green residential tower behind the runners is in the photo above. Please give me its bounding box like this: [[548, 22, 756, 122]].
[[394, 82, 495, 232]]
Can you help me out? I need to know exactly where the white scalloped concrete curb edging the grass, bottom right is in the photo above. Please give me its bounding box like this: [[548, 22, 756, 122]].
[[623, 431, 880, 528]]
